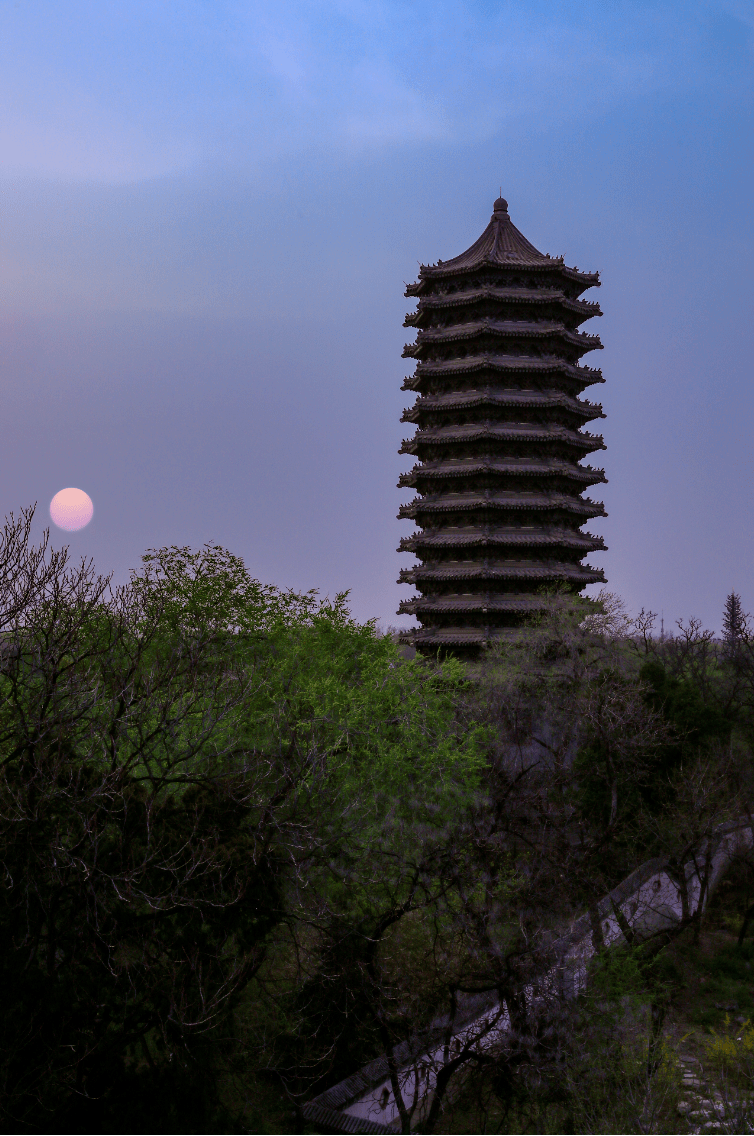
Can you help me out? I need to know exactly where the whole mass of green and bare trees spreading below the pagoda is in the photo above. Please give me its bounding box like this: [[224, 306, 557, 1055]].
[[0, 511, 754, 1131]]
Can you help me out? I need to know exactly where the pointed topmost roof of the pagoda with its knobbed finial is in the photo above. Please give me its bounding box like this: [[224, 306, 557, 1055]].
[[407, 198, 600, 295]]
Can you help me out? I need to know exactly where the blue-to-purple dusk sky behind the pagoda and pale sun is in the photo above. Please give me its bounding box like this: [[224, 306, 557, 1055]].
[[0, 0, 754, 630]]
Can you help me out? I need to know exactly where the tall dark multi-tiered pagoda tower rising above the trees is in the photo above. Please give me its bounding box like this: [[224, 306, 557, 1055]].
[[399, 198, 605, 653]]
